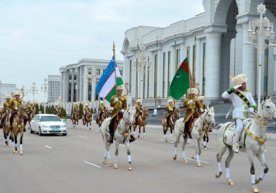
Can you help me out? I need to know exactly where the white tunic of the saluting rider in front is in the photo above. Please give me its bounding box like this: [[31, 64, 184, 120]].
[[221, 90, 256, 119]]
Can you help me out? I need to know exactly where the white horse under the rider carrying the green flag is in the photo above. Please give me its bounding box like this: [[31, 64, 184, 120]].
[[173, 107, 215, 167]]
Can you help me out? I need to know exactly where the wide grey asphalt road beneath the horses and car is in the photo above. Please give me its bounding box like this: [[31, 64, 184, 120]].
[[0, 122, 276, 193]]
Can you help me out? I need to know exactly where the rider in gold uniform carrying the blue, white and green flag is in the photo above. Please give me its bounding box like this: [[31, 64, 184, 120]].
[[108, 86, 135, 143]]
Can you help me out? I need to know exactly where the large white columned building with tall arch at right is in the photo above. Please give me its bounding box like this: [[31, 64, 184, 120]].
[[121, 0, 276, 106]]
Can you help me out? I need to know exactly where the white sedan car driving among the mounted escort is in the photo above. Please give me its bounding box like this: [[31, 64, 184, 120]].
[[30, 114, 67, 136]]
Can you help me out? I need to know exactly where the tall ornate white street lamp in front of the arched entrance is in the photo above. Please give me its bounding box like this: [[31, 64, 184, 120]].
[[248, 3, 274, 110]]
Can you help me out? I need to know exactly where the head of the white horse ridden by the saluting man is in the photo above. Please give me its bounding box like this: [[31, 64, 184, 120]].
[[258, 97, 276, 119]]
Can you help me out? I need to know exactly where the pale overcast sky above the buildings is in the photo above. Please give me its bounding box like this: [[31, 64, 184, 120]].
[[0, 0, 203, 88]]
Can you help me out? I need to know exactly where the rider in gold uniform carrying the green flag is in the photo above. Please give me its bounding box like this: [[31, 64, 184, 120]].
[[184, 87, 203, 138]]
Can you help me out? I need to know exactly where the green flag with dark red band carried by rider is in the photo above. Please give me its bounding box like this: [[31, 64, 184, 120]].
[[169, 57, 190, 100]]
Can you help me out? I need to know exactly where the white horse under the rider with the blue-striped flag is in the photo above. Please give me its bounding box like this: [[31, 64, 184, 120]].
[[100, 109, 134, 171]]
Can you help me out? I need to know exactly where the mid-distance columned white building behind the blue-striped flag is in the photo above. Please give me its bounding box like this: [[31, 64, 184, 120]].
[[60, 59, 124, 103]]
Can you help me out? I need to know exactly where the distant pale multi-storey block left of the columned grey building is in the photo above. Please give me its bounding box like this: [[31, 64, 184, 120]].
[[47, 75, 61, 103]]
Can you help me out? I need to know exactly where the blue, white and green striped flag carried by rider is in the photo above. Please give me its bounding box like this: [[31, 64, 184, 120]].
[[96, 57, 124, 102]]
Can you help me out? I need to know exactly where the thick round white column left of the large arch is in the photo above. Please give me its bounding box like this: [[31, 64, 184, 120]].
[[205, 32, 221, 98]]
